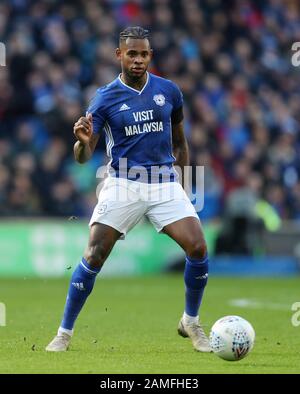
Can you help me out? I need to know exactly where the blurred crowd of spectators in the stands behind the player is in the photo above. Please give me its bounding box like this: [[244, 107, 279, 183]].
[[0, 0, 300, 220]]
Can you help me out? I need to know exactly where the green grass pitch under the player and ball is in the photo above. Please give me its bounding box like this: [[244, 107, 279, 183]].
[[0, 275, 300, 374]]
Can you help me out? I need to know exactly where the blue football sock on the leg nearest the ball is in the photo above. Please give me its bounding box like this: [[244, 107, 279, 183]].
[[184, 254, 208, 317]]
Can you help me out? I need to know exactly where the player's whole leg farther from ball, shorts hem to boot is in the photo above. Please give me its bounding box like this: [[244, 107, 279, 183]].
[[46, 223, 121, 352]]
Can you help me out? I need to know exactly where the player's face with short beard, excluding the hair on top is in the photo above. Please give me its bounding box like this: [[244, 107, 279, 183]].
[[116, 38, 152, 79]]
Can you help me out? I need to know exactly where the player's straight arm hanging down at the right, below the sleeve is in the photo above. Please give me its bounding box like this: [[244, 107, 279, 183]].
[[172, 107, 190, 174]]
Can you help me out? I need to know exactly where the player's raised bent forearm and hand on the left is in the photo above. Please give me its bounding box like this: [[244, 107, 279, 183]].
[[73, 114, 99, 164]]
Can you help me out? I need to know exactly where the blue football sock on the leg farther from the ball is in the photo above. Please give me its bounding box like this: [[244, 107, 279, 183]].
[[60, 258, 100, 331]]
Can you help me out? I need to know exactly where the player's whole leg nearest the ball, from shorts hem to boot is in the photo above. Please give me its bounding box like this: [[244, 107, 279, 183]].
[[163, 217, 211, 352]]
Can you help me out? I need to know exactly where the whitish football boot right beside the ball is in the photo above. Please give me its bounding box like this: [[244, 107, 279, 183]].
[[177, 319, 212, 353]]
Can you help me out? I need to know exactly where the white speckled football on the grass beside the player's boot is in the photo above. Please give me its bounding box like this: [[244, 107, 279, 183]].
[[209, 316, 255, 361]]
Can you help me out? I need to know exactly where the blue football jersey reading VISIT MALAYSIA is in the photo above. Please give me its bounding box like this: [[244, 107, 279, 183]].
[[87, 73, 183, 182]]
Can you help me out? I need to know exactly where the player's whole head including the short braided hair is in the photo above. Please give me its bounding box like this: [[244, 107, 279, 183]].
[[116, 26, 152, 79]]
